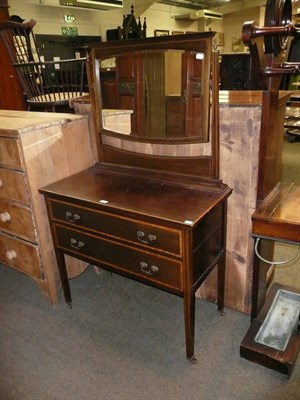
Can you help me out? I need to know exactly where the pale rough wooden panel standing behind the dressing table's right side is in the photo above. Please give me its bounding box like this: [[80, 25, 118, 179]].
[[197, 104, 261, 313]]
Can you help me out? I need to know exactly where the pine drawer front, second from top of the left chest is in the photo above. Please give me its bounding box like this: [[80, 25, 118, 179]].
[[0, 168, 30, 204]]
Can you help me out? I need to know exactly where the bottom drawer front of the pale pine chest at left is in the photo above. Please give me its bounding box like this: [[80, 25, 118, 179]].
[[0, 233, 41, 279]]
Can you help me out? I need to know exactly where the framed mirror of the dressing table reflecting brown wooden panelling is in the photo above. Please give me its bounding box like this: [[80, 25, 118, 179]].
[[92, 32, 214, 142]]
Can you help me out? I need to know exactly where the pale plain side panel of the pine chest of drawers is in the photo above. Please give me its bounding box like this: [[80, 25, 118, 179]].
[[21, 113, 93, 303]]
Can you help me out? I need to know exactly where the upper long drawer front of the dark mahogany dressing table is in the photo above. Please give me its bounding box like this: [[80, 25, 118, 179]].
[[51, 200, 182, 255]]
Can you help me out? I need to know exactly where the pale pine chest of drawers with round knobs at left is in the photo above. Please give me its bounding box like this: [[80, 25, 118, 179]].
[[0, 110, 92, 304]]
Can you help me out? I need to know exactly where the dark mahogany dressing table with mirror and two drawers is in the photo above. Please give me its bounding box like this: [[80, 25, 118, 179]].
[[40, 32, 231, 362]]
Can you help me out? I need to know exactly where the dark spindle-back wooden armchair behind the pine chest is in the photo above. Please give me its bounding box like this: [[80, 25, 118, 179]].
[[0, 19, 86, 112]]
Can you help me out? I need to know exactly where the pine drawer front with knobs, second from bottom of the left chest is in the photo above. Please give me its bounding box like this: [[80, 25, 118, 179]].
[[0, 200, 37, 241]]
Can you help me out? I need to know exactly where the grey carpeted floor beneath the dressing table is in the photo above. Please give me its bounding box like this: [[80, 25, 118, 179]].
[[0, 138, 300, 400]]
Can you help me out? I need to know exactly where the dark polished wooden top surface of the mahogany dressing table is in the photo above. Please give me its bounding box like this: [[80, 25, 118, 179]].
[[41, 164, 231, 226]]
